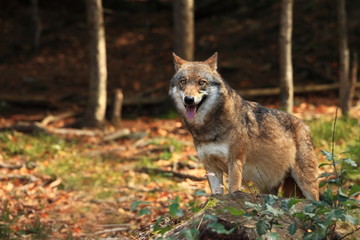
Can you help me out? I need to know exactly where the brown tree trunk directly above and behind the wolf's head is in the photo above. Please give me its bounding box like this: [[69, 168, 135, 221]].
[[173, 0, 194, 61]]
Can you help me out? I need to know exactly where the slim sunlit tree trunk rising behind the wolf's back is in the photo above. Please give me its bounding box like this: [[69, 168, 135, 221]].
[[279, 0, 294, 113]]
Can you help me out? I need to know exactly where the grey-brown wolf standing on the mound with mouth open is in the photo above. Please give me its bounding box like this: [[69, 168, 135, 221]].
[[169, 53, 319, 201]]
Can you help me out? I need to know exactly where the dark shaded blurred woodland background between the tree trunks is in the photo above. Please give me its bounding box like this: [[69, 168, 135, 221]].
[[0, 0, 360, 120]]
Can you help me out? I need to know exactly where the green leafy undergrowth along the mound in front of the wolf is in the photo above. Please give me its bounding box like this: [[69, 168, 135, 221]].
[[132, 151, 360, 240]]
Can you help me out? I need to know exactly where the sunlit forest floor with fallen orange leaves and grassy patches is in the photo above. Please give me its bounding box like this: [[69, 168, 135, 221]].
[[0, 96, 360, 239]]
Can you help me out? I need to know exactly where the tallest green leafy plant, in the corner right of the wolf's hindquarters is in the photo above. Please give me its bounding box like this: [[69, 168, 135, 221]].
[[295, 151, 360, 239]]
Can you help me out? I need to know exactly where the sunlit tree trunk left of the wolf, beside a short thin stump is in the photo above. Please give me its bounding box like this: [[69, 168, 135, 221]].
[[83, 0, 107, 127]]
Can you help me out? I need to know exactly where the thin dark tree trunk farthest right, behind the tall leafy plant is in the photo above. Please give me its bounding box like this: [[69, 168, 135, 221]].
[[337, 0, 351, 116]]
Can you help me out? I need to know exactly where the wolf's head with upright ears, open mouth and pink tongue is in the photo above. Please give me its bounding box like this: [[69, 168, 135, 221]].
[[169, 53, 223, 121]]
